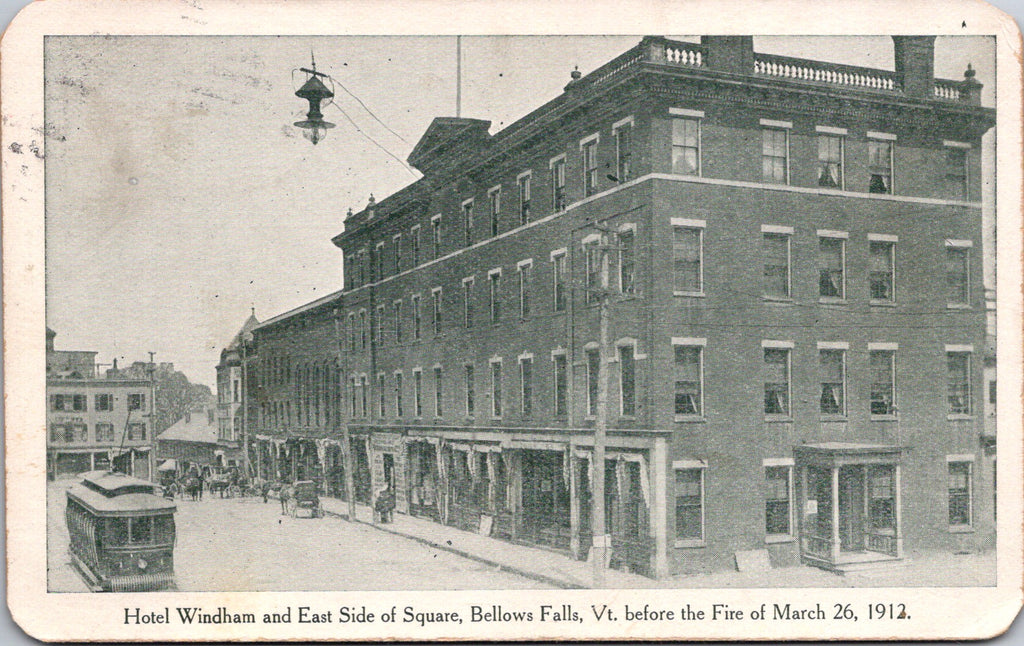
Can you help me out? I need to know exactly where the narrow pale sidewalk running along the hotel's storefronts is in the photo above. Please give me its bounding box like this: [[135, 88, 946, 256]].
[[321, 497, 656, 589]]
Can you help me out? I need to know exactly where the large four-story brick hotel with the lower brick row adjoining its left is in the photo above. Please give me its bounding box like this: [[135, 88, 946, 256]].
[[250, 36, 994, 576]]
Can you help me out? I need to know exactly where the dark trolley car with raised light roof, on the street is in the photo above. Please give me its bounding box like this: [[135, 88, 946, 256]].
[[65, 471, 177, 592]]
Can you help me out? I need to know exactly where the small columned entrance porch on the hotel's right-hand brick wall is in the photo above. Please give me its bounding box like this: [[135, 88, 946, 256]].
[[795, 442, 903, 572]]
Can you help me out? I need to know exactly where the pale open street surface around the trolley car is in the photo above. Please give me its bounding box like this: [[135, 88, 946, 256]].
[[47, 480, 546, 592]]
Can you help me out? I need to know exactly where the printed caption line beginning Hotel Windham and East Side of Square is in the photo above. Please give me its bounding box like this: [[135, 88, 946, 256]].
[[124, 603, 910, 627]]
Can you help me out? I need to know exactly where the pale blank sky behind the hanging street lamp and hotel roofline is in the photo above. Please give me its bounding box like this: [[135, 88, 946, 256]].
[[45, 36, 994, 386]]
